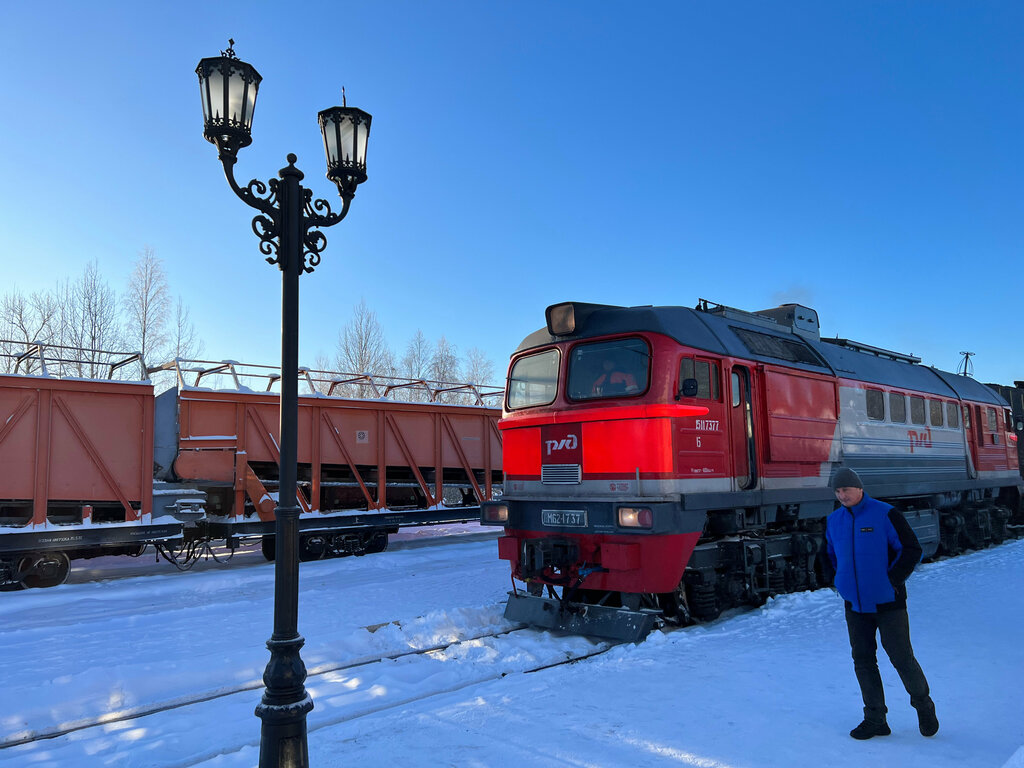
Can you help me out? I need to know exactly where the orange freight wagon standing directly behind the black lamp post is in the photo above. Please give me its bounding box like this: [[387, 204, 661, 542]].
[[157, 361, 502, 559]]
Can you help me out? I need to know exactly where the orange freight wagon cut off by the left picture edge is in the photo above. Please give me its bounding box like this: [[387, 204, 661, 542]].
[[0, 348, 188, 587]]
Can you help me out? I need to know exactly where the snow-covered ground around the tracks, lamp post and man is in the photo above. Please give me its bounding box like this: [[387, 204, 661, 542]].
[[0, 535, 1024, 768]]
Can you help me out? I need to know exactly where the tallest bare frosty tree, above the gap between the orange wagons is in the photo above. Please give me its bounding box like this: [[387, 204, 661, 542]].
[[124, 246, 172, 360]]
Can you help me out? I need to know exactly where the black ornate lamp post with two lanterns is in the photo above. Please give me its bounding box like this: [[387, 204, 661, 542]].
[[196, 40, 371, 768]]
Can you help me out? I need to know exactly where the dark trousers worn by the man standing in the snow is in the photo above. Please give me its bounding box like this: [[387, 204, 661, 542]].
[[846, 605, 932, 723]]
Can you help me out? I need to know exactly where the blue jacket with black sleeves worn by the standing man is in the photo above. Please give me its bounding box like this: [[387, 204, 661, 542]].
[[825, 494, 921, 613]]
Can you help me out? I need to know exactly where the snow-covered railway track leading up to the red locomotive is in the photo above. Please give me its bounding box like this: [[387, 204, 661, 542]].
[[0, 622, 614, 762]]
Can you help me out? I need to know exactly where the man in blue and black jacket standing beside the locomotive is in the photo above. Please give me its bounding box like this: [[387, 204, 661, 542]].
[[825, 468, 939, 739]]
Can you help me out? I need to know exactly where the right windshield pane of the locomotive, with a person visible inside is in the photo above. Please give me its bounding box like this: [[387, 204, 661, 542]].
[[566, 338, 650, 400]]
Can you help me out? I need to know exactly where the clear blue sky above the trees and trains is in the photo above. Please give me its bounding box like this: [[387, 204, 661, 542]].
[[0, 0, 1024, 382]]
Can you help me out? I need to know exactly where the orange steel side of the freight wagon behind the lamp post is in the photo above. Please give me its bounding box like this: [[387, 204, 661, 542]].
[[174, 389, 501, 518]]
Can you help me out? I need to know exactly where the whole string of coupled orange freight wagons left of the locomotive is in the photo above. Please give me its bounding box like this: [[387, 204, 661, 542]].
[[0, 341, 501, 590]]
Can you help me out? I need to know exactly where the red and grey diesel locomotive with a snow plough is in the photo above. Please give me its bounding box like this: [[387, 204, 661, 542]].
[[481, 300, 1024, 640]]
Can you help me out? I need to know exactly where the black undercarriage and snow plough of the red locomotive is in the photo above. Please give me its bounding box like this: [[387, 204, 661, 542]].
[[506, 492, 1024, 641]]
